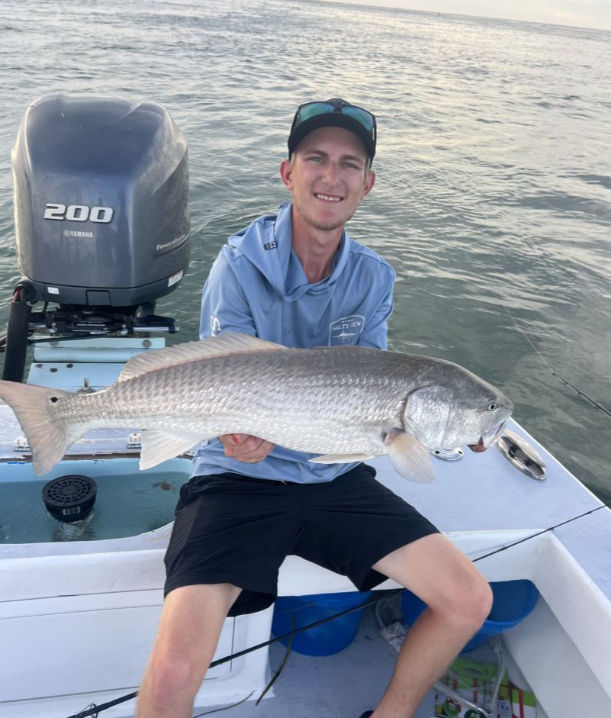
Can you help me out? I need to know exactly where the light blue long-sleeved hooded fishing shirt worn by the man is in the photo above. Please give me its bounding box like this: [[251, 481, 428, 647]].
[[191, 203, 395, 484]]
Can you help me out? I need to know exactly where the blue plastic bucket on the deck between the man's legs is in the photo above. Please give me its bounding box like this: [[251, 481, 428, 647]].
[[272, 591, 371, 656]]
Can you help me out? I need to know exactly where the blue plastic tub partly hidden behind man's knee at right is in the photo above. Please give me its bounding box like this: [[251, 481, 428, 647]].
[[401, 580, 539, 653]]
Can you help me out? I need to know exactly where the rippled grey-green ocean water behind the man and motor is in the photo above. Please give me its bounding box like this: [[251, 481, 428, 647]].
[[0, 0, 611, 498]]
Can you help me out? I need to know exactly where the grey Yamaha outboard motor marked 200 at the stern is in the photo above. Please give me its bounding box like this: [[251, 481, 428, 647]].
[[3, 93, 190, 381]]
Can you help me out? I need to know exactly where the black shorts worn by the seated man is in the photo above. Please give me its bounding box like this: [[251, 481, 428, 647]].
[[165, 464, 438, 616]]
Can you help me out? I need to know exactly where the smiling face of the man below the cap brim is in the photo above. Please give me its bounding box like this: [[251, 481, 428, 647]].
[[280, 127, 375, 231]]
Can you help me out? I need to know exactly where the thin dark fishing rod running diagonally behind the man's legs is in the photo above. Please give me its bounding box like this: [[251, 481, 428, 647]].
[[68, 504, 611, 718]]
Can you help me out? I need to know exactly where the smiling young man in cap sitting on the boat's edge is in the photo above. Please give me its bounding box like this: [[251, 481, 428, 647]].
[[137, 99, 492, 718]]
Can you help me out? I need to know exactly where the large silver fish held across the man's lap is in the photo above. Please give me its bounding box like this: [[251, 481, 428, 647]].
[[0, 333, 513, 483]]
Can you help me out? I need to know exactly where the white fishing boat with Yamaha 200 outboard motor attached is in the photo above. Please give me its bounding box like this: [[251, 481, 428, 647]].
[[0, 94, 611, 718]]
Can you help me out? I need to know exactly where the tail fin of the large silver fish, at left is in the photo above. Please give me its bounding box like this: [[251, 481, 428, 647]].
[[0, 381, 79, 476]]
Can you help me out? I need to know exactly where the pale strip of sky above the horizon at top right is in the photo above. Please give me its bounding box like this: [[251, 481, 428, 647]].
[[318, 0, 611, 30]]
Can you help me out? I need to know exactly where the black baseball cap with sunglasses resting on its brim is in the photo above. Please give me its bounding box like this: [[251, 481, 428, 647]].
[[288, 98, 377, 160]]
